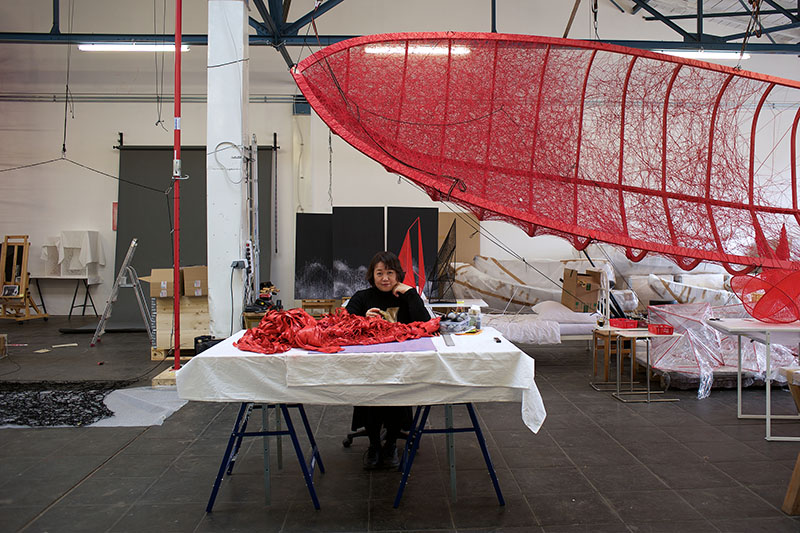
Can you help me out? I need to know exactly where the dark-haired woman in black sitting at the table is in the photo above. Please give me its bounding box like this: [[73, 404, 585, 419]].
[[346, 252, 431, 470]]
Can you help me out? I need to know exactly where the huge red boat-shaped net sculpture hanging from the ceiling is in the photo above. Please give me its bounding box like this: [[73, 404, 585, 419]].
[[293, 33, 800, 273]]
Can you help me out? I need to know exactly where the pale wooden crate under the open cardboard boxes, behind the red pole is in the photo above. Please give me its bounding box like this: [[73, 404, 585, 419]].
[[156, 296, 210, 351]]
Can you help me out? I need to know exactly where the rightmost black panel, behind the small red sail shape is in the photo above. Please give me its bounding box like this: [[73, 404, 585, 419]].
[[386, 207, 439, 290]]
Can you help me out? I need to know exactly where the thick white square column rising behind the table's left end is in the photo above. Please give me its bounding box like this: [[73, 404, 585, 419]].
[[205, 0, 250, 337]]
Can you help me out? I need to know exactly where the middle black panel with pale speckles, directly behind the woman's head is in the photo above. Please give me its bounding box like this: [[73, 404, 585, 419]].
[[333, 207, 384, 298]]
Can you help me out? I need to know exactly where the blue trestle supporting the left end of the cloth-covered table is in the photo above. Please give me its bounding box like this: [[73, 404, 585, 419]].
[[206, 402, 325, 513]]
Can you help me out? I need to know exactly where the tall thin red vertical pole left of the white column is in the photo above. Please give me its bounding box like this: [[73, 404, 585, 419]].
[[172, 0, 182, 370]]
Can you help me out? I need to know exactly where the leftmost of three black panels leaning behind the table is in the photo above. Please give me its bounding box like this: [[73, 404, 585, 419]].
[[294, 213, 334, 300]]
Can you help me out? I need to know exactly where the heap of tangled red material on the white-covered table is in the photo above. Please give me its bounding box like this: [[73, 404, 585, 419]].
[[234, 309, 439, 354]]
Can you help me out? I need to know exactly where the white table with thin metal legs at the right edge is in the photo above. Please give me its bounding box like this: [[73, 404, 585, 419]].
[[705, 318, 800, 441]]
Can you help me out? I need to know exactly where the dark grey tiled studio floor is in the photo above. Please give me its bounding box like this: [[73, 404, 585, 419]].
[[0, 319, 800, 532]]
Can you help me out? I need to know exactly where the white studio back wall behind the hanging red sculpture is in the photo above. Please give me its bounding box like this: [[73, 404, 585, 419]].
[[0, 0, 800, 314]]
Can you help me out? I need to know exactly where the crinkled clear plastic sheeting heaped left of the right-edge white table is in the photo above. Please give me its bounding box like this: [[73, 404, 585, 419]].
[[648, 303, 797, 399]]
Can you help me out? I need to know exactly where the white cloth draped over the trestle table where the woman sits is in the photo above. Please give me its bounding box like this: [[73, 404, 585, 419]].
[[176, 327, 547, 432]]
